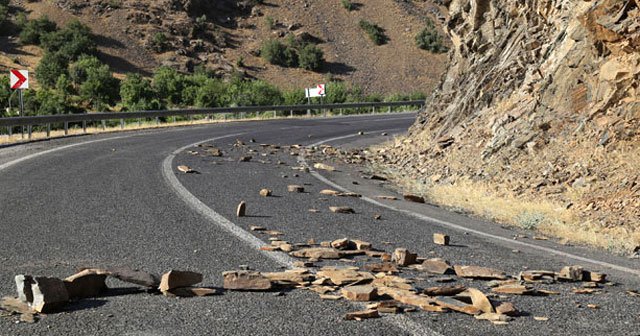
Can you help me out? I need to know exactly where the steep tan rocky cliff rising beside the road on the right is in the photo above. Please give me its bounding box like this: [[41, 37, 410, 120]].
[[374, 0, 640, 248]]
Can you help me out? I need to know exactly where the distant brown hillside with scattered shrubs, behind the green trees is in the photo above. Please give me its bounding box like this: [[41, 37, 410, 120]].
[[0, 0, 446, 94]]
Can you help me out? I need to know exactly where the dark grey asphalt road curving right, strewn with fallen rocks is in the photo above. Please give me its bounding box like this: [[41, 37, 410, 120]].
[[0, 114, 640, 335]]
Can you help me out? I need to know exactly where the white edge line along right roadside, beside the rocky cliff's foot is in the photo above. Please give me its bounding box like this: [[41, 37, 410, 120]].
[[298, 134, 640, 276]]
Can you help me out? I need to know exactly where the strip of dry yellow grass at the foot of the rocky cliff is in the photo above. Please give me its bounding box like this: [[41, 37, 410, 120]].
[[378, 163, 640, 254]]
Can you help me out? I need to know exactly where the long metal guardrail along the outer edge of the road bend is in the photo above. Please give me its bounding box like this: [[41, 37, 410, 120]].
[[0, 100, 425, 138]]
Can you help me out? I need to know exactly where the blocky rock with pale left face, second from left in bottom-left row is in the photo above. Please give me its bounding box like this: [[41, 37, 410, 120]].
[[31, 277, 69, 313]]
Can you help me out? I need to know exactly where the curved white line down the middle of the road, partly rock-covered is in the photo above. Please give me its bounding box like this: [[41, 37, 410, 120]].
[[162, 129, 443, 336]]
